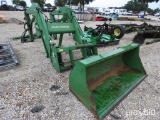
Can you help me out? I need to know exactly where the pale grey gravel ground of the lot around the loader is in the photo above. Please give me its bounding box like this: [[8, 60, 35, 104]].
[[0, 11, 160, 120]]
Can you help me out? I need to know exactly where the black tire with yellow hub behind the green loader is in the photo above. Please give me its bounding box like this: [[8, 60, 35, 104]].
[[112, 25, 125, 39]]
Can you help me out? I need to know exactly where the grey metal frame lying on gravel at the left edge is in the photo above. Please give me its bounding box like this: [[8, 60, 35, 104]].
[[0, 43, 19, 71]]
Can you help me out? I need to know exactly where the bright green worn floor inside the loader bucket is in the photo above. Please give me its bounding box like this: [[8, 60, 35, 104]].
[[92, 72, 145, 117]]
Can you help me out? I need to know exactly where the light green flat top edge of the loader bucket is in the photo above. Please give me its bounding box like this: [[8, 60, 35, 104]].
[[77, 43, 140, 66]]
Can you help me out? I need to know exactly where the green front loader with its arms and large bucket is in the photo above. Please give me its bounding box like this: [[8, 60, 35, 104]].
[[22, 3, 147, 118]]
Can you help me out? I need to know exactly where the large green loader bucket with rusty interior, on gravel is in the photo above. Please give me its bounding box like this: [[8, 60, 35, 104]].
[[69, 43, 147, 118]]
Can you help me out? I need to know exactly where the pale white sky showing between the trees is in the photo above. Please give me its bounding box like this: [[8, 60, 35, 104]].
[[3, 0, 160, 9]]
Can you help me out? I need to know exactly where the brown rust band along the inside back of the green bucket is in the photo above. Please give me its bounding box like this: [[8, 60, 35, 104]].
[[88, 64, 141, 90]]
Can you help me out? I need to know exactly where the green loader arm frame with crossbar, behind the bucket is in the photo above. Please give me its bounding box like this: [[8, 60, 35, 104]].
[[24, 3, 98, 72]]
